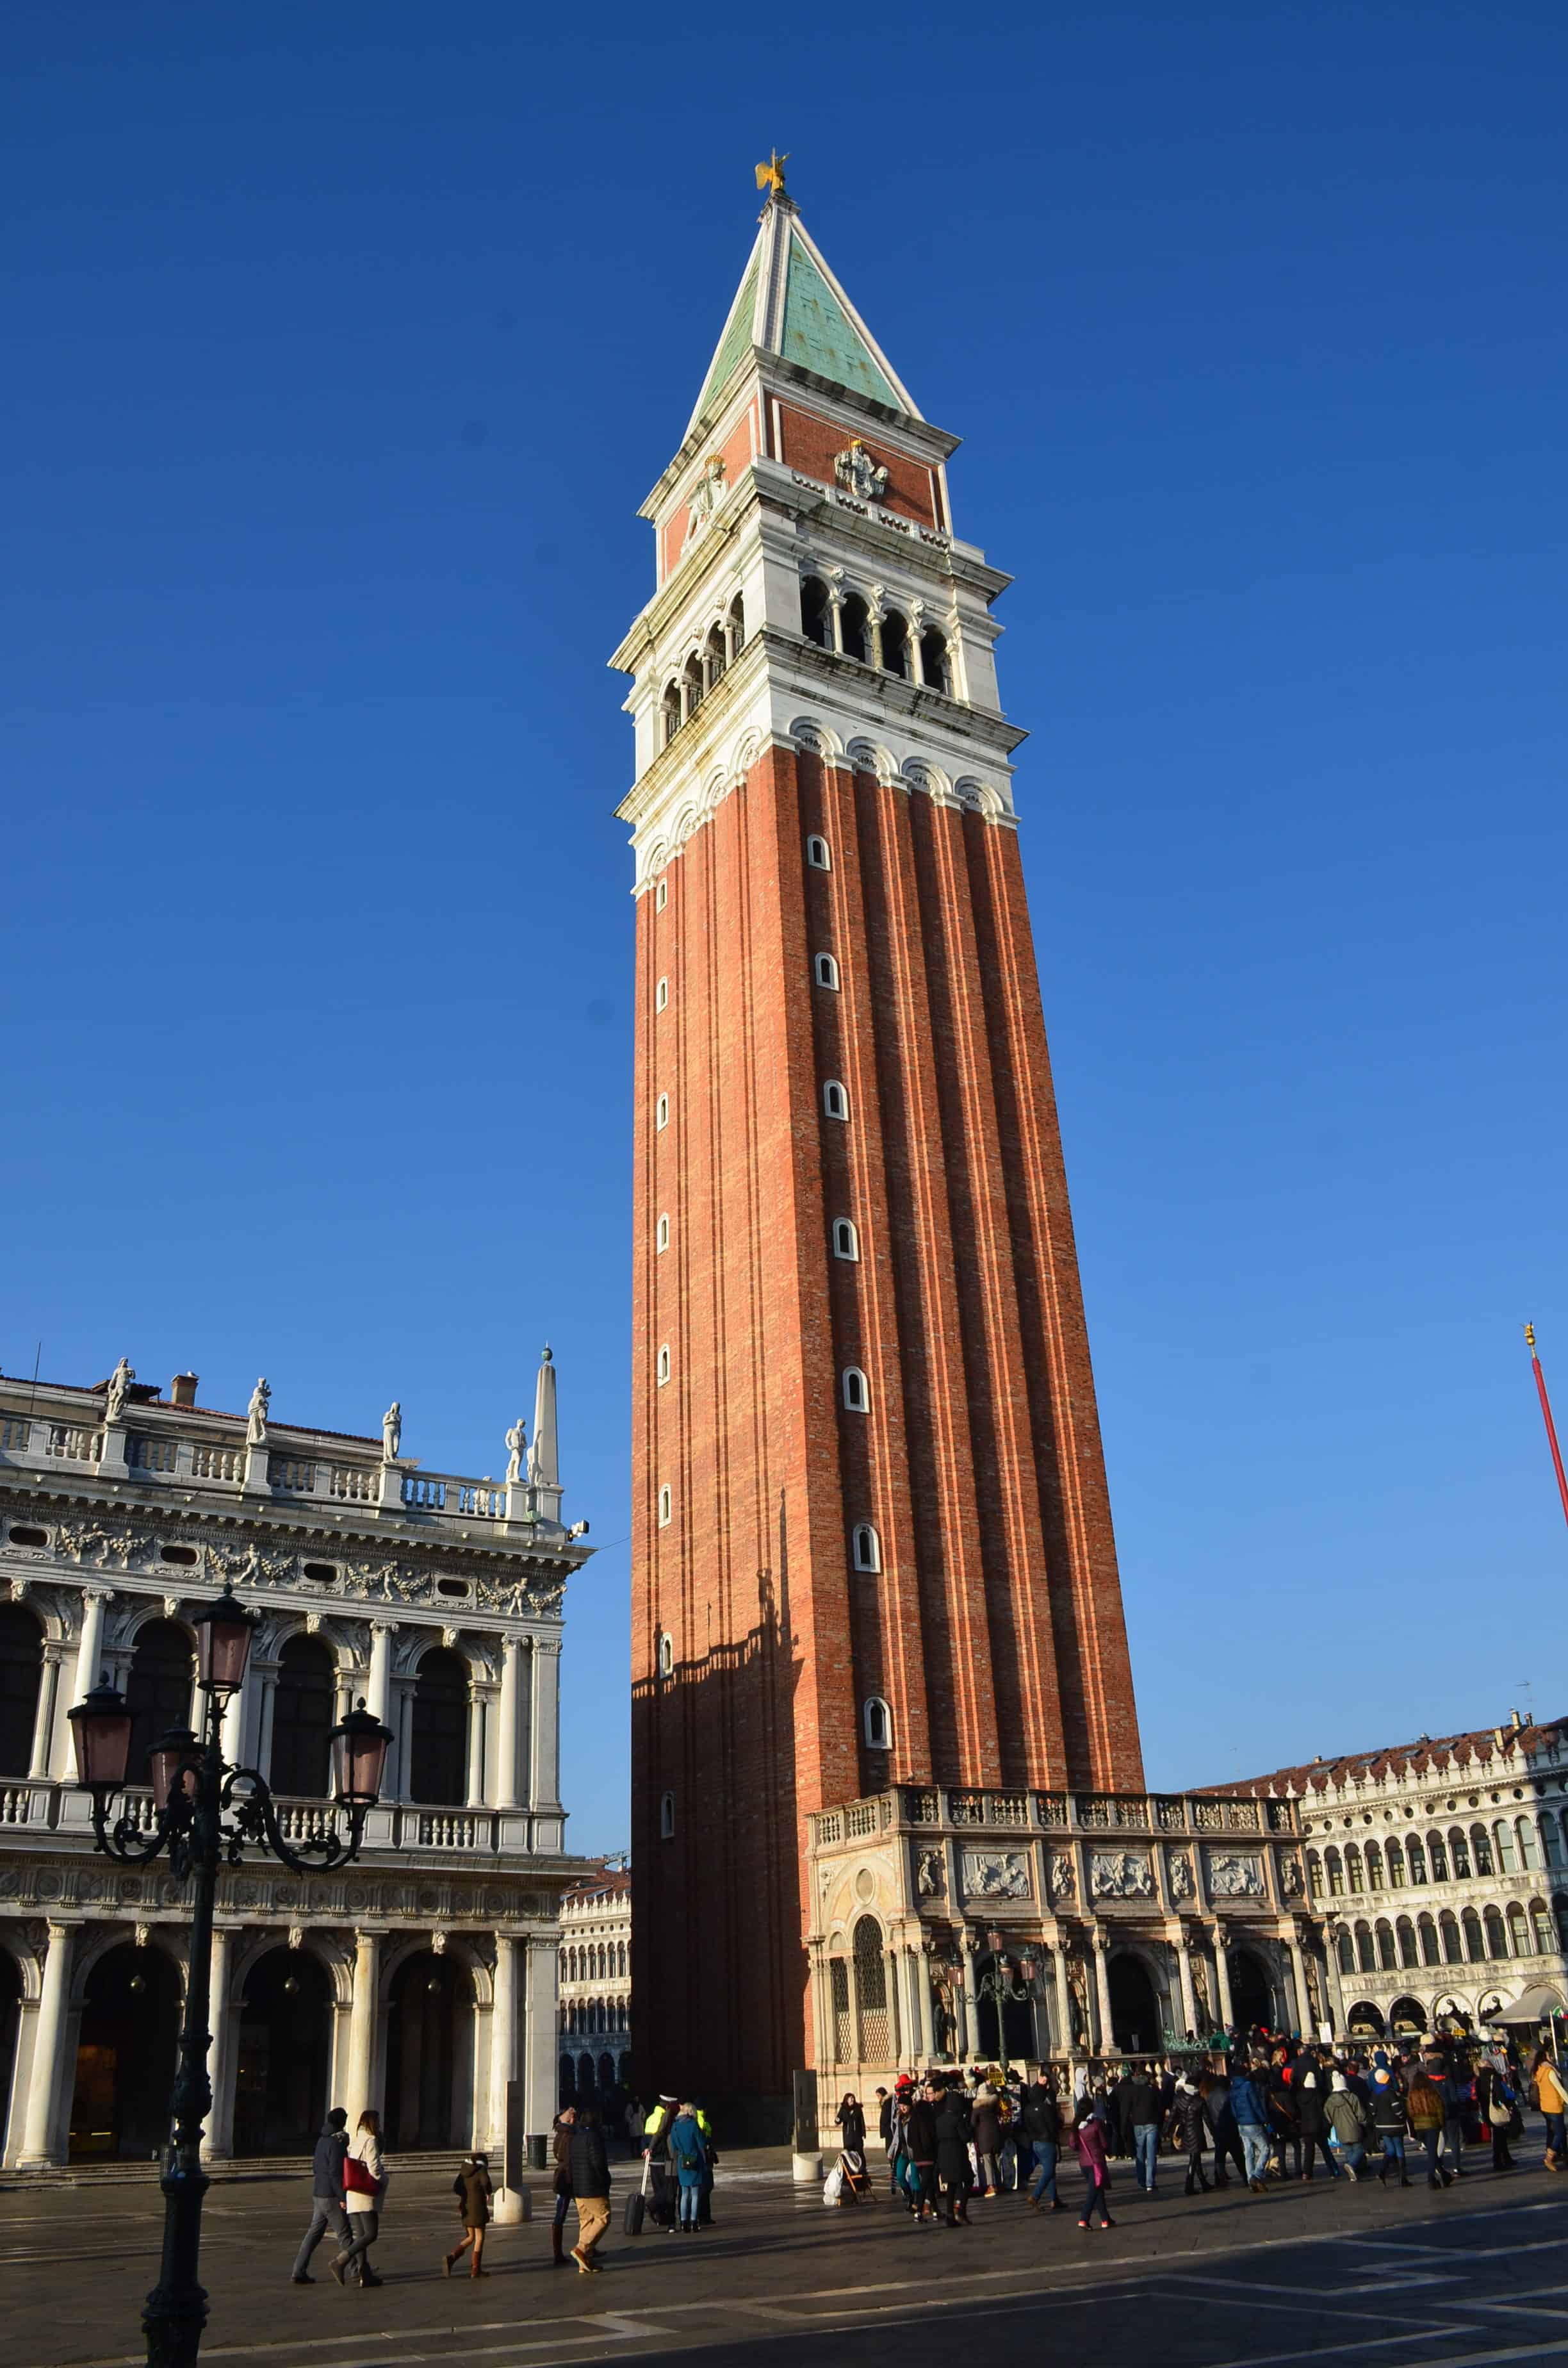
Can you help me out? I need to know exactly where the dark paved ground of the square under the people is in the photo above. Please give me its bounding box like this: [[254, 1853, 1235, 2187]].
[[0, 2148, 1568, 2368]]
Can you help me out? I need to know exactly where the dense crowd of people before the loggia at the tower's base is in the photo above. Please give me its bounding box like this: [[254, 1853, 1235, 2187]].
[[822, 2039, 1568, 2228]]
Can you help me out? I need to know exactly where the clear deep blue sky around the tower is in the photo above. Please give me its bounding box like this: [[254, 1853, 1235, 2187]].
[[0, 0, 1568, 1847]]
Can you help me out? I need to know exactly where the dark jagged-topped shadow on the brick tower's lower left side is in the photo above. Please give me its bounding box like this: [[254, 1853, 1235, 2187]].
[[632, 1497, 810, 2146]]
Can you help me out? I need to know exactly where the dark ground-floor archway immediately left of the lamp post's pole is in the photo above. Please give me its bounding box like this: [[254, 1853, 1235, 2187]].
[[71, 1942, 180, 2162]]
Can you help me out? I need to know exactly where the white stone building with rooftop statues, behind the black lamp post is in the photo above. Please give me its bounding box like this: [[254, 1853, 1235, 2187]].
[[0, 1350, 590, 2164]]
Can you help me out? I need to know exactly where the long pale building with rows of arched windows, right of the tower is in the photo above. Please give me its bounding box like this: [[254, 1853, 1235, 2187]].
[[1241, 1712, 1568, 2039]]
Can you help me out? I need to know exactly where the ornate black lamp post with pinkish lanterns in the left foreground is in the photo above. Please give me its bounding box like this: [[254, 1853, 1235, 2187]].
[[71, 1586, 393, 2368]]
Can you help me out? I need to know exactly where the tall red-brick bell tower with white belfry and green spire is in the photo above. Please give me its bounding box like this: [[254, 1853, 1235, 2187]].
[[614, 166, 1141, 2134]]
